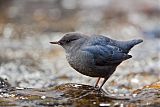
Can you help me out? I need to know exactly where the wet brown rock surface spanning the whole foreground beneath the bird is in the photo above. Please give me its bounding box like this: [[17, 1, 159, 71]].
[[0, 82, 160, 106]]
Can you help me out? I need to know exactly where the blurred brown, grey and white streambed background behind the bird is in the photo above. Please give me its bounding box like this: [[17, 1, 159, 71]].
[[0, 0, 160, 93]]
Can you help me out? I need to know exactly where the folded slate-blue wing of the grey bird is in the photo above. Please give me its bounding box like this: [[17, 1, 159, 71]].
[[82, 45, 132, 66]]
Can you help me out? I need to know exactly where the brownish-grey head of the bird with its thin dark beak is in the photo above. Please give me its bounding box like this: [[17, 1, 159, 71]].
[[50, 32, 85, 50]]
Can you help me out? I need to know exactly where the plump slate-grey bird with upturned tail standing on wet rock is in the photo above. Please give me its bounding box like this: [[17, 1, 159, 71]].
[[50, 32, 143, 89]]
